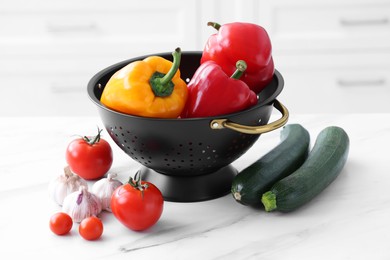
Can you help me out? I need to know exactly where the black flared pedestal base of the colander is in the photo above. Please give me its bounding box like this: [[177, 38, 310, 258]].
[[139, 165, 238, 202]]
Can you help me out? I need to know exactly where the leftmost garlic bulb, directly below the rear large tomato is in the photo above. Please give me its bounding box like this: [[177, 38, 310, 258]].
[[49, 166, 88, 206]]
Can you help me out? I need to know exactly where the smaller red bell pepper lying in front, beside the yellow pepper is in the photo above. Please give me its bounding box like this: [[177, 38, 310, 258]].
[[182, 60, 257, 118]]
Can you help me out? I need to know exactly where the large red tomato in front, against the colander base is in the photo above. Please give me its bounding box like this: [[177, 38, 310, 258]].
[[111, 173, 164, 231]]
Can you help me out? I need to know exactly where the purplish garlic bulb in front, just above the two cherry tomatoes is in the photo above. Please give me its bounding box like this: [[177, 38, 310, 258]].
[[62, 186, 102, 223]]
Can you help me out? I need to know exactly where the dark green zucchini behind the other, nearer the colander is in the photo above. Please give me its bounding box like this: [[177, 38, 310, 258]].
[[231, 124, 310, 206]]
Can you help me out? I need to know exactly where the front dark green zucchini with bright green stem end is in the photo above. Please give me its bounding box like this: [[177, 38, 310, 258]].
[[261, 126, 349, 212]]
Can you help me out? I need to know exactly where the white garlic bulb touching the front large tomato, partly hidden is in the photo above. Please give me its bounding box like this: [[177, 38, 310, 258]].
[[92, 173, 123, 212]]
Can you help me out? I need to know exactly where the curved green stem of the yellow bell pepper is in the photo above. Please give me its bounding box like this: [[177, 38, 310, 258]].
[[150, 48, 181, 97]]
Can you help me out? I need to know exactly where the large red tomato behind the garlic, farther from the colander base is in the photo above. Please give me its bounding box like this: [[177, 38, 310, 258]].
[[66, 129, 113, 180]]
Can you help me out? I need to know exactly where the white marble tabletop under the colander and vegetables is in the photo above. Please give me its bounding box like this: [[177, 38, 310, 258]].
[[0, 113, 390, 260]]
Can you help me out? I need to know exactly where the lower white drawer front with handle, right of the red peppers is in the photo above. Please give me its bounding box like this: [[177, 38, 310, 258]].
[[275, 54, 390, 113]]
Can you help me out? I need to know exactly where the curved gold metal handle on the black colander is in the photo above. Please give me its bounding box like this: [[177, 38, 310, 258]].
[[210, 100, 289, 134]]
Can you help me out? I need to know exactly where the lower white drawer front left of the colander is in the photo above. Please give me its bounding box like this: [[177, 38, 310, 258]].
[[0, 57, 125, 116]]
